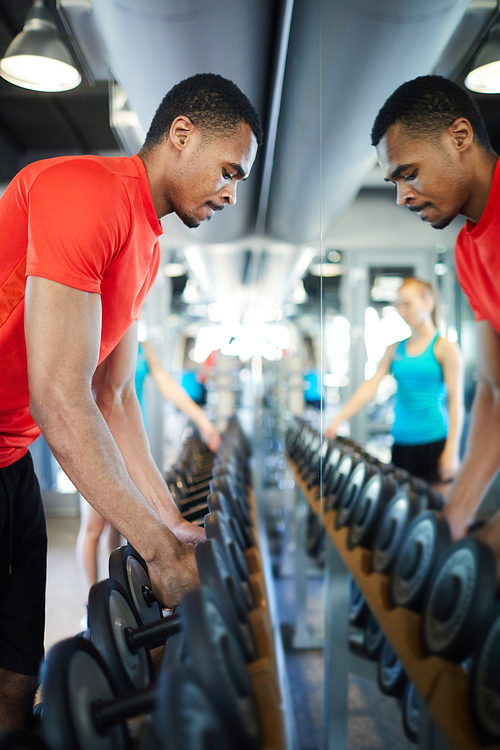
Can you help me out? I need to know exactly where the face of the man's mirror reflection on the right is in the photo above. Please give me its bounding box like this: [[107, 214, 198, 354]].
[[377, 122, 469, 229]]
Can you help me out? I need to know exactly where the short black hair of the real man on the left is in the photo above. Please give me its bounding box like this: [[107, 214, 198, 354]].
[[144, 73, 263, 149]]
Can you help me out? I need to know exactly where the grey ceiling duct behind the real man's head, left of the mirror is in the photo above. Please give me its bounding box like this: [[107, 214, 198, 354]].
[[93, 0, 275, 242]]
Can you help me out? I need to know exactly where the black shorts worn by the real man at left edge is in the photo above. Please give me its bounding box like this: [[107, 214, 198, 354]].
[[0, 453, 47, 676]]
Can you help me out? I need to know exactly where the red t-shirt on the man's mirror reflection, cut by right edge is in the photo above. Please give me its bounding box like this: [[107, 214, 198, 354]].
[[455, 160, 500, 333]]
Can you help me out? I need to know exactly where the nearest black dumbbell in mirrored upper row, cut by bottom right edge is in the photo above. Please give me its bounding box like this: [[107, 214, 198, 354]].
[[468, 605, 500, 744]]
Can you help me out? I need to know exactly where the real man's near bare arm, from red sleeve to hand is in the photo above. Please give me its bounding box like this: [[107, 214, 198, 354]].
[[25, 277, 199, 605]]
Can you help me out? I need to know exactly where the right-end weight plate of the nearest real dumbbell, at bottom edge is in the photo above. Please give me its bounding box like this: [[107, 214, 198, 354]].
[[151, 664, 234, 750]]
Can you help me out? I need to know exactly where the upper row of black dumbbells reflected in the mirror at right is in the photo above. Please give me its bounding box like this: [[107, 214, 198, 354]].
[[286, 420, 500, 742]]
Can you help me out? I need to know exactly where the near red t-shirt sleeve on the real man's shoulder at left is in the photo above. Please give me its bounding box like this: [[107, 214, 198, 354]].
[[26, 160, 130, 293]]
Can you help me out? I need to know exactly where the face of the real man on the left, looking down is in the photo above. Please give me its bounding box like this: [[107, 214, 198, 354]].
[[169, 122, 257, 227]]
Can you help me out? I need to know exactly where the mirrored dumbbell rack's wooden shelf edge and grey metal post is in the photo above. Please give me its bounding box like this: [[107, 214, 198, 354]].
[[292, 464, 500, 750]]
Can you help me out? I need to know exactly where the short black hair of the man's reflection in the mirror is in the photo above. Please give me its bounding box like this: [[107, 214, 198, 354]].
[[372, 76, 491, 151]]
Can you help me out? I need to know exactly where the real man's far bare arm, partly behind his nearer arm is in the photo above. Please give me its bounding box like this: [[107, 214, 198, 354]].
[[92, 323, 205, 542]]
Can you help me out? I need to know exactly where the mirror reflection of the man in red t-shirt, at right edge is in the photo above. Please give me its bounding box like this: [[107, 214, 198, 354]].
[[372, 76, 500, 560]]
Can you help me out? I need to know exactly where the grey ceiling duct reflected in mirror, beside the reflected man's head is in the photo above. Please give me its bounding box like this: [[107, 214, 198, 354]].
[[266, 0, 469, 242]]
